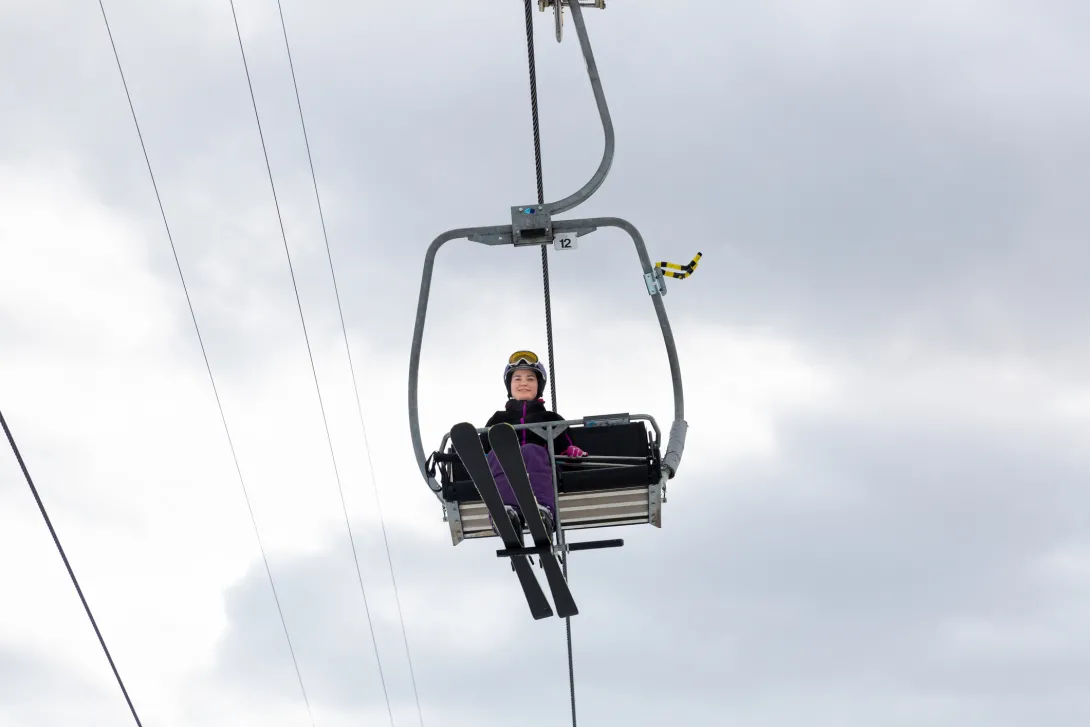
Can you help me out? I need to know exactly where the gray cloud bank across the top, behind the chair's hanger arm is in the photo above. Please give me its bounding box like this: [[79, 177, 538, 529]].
[[12, 3, 1090, 381]]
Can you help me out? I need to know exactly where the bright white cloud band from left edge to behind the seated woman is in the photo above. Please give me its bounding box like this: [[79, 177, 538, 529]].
[[2, 156, 820, 724]]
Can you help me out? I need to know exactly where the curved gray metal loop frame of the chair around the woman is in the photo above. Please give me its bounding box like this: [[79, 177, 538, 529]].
[[409, 217, 689, 499]]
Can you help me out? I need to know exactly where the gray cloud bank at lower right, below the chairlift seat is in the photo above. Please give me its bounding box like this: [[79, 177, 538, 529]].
[[200, 366, 1090, 725]]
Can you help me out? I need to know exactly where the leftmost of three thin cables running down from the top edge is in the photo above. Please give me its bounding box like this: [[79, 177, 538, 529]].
[[94, 0, 315, 727]]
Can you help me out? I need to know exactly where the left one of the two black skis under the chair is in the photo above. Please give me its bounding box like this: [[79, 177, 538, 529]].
[[450, 422, 553, 619]]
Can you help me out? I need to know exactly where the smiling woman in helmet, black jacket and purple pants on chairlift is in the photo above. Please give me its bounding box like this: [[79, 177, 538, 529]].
[[481, 351, 586, 536]]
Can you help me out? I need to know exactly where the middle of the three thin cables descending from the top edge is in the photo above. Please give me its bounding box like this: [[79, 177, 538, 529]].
[[223, 0, 393, 727]]
